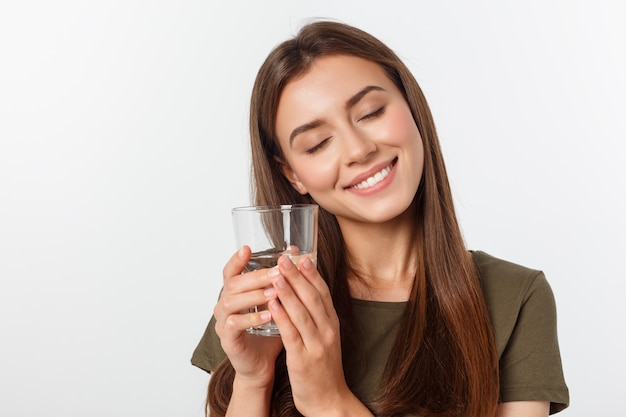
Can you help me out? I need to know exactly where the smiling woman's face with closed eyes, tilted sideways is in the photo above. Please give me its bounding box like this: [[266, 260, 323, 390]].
[[276, 55, 424, 223]]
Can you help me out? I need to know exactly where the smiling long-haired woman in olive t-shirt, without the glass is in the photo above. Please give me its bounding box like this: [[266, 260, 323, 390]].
[[192, 22, 569, 417]]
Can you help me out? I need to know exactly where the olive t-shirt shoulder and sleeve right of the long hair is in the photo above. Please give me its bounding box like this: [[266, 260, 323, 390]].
[[473, 252, 569, 414]]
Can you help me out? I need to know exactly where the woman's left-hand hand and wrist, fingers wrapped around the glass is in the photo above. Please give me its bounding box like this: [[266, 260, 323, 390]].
[[213, 246, 283, 388]]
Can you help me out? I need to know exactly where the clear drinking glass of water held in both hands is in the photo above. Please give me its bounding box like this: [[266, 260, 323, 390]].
[[232, 204, 318, 336]]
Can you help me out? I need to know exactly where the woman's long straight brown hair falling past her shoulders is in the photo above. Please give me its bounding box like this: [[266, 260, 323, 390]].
[[207, 21, 499, 417]]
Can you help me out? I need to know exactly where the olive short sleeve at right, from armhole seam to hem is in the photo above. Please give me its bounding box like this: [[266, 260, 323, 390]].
[[500, 272, 569, 414]]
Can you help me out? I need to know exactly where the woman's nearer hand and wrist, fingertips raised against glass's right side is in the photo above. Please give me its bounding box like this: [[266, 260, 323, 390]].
[[268, 256, 354, 415]]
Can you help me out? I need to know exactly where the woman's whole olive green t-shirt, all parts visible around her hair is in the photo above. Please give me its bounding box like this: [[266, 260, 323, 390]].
[[191, 251, 569, 414]]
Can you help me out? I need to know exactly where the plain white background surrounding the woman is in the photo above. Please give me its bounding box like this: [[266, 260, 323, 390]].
[[0, 0, 626, 417]]
